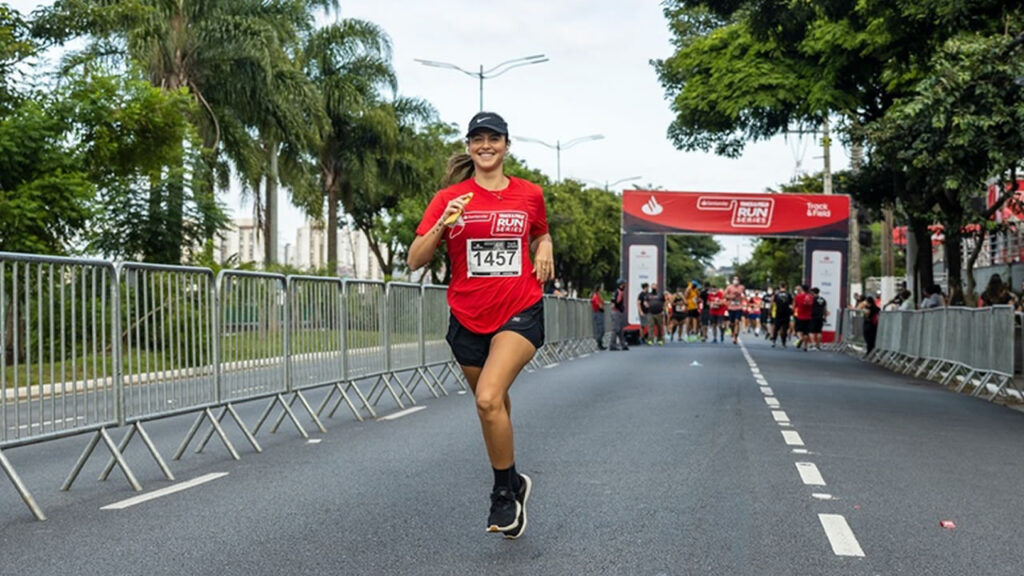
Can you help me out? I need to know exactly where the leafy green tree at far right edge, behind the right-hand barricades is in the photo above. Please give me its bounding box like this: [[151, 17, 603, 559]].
[[868, 35, 1024, 301]]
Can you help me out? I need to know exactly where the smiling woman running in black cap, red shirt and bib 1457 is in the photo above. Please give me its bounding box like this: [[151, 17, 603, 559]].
[[408, 112, 554, 538]]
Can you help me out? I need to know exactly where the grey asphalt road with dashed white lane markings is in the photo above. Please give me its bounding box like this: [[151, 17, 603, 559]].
[[0, 336, 1024, 576]]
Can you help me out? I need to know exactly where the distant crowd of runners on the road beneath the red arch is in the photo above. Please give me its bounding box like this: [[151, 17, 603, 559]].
[[637, 277, 828, 351]]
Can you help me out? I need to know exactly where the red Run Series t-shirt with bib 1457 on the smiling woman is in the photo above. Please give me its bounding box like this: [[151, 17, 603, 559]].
[[416, 176, 548, 334]]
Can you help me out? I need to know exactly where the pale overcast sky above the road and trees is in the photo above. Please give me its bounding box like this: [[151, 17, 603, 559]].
[[12, 0, 849, 265]]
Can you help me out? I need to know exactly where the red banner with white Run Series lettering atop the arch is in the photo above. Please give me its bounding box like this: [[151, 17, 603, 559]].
[[623, 190, 850, 239]]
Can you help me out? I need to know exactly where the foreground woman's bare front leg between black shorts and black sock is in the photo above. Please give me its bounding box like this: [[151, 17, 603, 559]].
[[467, 331, 537, 469]]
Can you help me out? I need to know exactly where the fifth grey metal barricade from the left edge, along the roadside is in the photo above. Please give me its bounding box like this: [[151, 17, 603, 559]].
[[343, 279, 407, 409]]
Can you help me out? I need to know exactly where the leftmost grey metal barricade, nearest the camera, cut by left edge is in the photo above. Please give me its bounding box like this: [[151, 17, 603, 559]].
[[0, 253, 124, 520]]
